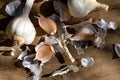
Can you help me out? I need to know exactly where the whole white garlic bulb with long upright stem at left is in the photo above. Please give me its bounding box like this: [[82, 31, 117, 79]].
[[6, 0, 36, 44]]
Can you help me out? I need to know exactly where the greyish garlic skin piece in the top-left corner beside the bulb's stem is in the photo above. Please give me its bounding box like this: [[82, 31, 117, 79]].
[[5, 0, 21, 16]]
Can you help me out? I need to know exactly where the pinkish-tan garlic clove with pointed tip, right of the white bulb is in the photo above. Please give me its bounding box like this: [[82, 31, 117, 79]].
[[38, 17, 57, 35]]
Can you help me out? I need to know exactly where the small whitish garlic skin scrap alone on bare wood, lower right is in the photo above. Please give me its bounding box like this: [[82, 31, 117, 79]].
[[81, 57, 95, 67]]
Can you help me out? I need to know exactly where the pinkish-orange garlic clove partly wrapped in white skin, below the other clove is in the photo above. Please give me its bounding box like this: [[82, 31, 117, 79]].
[[34, 42, 55, 63]]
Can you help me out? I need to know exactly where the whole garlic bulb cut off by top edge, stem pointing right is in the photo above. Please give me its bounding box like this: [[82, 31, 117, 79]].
[[67, 0, 109, 18]]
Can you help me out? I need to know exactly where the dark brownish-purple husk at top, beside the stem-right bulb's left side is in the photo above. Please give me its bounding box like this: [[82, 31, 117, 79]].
[[53, 0, 71, 21]]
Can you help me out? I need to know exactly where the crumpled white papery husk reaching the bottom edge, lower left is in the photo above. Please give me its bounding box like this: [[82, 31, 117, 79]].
[[22, 54, 43, 80]]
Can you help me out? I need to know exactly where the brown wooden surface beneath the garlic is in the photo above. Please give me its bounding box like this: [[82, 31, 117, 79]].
[[0, 0, 120, 80]]
